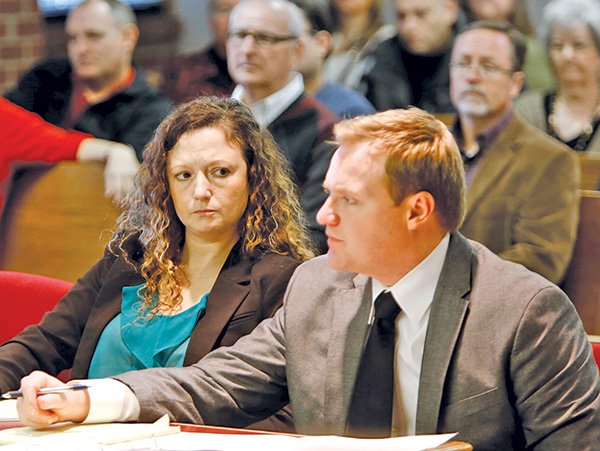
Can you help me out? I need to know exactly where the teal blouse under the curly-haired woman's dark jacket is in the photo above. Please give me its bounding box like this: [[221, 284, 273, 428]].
[[88, 285, 209, 378]]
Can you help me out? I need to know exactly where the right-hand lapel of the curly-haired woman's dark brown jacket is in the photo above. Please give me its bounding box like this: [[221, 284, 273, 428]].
[[183, 260, 251, 366]]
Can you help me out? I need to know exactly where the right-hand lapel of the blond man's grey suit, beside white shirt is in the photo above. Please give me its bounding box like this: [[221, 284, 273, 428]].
[[416, 233, 473, 434]]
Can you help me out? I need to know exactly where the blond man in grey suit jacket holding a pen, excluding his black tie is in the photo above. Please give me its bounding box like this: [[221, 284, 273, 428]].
[[17, 109, 600, 450]]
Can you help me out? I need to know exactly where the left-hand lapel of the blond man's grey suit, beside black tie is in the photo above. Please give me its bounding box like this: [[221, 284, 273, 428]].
[[324, 275, 371, 425]]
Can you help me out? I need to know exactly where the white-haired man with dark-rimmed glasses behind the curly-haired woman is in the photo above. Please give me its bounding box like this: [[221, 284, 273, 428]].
[[227, 0, 339, 252]]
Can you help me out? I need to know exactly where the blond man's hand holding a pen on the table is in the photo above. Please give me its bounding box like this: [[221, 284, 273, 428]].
[[17, 371, 90, 429]]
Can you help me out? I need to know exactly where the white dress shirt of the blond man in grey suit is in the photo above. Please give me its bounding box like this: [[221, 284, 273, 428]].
[[372, 234, 450, 436]]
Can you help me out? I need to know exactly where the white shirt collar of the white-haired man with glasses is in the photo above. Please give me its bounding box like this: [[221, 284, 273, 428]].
[[231, 73, 304, 127]]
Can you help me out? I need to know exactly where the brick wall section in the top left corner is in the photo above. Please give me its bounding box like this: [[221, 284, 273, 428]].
[[0, 0, 44, 93]]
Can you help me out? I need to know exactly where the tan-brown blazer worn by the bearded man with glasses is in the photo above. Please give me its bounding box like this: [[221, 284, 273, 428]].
[[460, 114, 579, 283]]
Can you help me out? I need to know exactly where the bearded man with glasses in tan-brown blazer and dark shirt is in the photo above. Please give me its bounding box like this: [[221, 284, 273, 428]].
[[450, 21, 579, 283]]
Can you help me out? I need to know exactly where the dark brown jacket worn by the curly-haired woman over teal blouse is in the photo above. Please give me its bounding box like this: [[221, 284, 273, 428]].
[[0, 238, 298, 392]]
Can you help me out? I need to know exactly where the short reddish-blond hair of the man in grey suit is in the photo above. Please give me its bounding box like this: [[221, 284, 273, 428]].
[[334, 108, 465, 231]]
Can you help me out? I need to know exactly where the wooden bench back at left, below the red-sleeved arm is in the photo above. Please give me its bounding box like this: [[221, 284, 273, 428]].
[[0, 161, 120, 282]]
